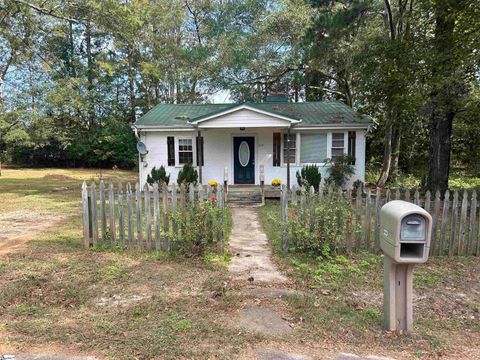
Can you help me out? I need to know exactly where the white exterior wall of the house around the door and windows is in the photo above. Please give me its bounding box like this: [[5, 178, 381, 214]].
[[140, 128, 365, 185]]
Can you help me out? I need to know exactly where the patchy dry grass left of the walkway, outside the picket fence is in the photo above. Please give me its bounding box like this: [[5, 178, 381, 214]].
[[0, 169, 261, 359]]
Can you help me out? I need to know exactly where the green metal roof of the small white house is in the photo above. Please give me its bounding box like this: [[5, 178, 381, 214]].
[[135, 101, 372, 127]]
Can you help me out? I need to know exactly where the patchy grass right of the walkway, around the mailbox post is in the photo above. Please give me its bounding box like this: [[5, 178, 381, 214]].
[[261, 201, 480, 358]]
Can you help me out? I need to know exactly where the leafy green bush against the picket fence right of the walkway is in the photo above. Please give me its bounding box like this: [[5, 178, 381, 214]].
[[287, 196, 355, 256]]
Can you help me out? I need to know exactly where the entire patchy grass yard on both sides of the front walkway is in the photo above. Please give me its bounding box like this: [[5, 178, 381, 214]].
[[0, 169, 480, 359]]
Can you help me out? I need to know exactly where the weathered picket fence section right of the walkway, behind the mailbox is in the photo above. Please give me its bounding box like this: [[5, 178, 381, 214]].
[[280, 186, 480, 256]]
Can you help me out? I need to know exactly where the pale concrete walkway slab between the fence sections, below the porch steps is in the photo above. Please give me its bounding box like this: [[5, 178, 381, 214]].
[[229, 205, 287, 284]]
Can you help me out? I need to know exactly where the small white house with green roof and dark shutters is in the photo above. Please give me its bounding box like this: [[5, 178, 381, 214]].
[[134, 99, 371, 185]]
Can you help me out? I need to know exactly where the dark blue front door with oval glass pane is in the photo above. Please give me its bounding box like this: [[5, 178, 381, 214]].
[[233, 136, 255, 184]]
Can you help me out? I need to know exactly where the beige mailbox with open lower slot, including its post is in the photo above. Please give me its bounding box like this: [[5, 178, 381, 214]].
[[380, 200, 432, 332]]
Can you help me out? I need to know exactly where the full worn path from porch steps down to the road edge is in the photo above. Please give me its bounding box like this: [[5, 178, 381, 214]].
[[228, 205, 398, 360]]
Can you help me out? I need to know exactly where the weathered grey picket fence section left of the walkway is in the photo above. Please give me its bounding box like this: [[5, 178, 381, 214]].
[[82, 181, 225, 251]]
